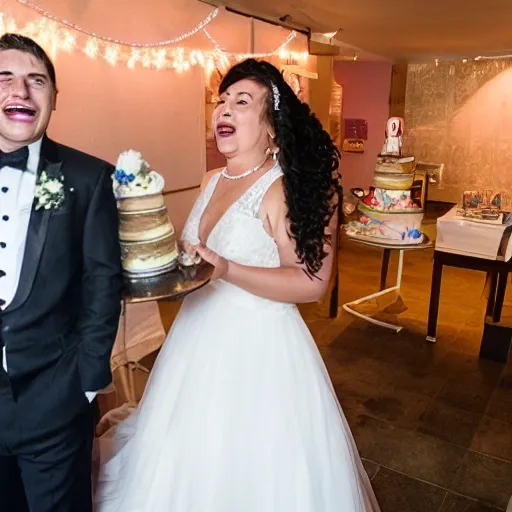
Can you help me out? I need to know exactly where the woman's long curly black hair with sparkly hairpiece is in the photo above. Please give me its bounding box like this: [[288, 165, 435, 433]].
[[219, 59, 342, 277]]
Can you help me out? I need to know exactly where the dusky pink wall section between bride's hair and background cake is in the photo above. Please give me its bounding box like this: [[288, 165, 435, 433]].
[[334, 62, 391, 194]]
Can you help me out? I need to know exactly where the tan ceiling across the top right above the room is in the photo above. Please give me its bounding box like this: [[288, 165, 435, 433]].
[[208, 0, 512, 61]]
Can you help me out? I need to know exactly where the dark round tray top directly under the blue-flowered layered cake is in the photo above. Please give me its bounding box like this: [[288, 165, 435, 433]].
[[123, 261, 214, 303]]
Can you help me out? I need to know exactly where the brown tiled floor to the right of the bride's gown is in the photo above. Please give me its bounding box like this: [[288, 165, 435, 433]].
[[101, 210, 512, 512]]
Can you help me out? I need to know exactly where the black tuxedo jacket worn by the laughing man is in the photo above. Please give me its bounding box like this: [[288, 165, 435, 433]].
[[0, 137, 121, 428]]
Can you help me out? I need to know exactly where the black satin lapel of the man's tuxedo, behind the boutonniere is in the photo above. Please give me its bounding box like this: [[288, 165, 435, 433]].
[[4, 136, 62, 313]]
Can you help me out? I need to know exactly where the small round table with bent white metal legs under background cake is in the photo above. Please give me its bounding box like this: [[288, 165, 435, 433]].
[[343, 235, 434, 333]]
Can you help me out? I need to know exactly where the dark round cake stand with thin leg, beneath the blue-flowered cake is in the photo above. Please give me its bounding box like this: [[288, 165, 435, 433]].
[[118, 261, 214, 407]]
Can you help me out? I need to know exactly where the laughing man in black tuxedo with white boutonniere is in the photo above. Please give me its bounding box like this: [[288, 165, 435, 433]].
[[0, 34, 121, 512]]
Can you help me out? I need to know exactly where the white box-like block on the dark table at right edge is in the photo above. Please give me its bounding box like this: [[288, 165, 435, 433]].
[[436, 206, 512, 261]]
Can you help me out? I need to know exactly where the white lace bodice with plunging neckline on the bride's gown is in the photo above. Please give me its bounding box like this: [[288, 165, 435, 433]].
[[182, 164, 283, 267]]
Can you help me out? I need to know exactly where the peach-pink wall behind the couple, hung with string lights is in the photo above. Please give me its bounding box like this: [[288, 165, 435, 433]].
[[2, 0, 307, 230]]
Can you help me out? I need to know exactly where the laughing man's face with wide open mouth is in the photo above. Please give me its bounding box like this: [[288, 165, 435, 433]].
[[0, 50, 56, 153]]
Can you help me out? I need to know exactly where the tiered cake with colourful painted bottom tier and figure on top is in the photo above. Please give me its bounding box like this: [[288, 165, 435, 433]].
[[347, 117, 423, 245]]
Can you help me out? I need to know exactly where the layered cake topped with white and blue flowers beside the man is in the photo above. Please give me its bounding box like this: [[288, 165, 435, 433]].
[[112, 150, 178, 276]]
